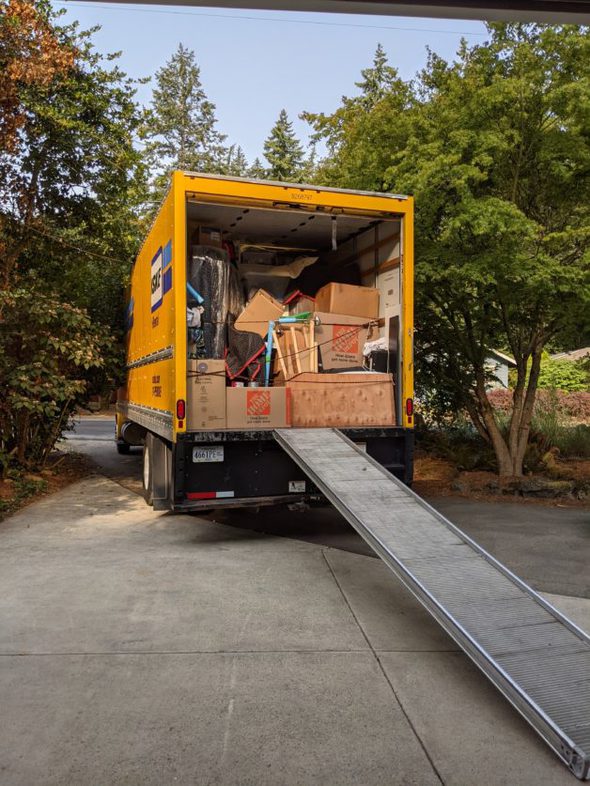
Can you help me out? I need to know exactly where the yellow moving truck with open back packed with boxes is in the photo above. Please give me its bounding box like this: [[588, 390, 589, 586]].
[[116, 172, 414, 510]]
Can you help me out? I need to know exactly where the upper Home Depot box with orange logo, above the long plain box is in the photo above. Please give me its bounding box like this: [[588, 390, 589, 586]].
[[315, 312, 377, 371]]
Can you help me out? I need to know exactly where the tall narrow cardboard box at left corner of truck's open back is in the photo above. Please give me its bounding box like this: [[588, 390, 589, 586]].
[[186, 360, 226, 431]]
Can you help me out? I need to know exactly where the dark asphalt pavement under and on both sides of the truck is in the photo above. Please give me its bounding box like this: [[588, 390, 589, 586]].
[[68, 417, 590, 598]]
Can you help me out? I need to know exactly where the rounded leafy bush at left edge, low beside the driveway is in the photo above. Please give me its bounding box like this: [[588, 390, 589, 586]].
[[0, 285, 110, 476]]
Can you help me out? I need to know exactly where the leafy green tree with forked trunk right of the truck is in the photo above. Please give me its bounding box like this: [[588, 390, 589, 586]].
[[307, 24, 590, 475]]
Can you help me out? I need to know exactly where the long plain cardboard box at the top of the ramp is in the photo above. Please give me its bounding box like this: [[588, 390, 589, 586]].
[[286, 372, 395, 428]]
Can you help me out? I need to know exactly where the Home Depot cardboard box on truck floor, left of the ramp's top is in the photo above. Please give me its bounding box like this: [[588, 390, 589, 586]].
[[226, 388, 291, 429]]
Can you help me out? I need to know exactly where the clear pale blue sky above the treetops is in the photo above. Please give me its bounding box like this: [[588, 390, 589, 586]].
[[53, 0, 485, 162]]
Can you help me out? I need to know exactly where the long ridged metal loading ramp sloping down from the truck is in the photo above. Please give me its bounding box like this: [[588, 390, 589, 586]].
[[274, 428, 590, 780]]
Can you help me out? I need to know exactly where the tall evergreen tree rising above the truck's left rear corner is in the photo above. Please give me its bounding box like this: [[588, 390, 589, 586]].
[[143, 44, 227, 190]]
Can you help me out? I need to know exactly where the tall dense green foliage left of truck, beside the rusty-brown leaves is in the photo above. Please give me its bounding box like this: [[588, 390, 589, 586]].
[[0, 6, 144, 466]]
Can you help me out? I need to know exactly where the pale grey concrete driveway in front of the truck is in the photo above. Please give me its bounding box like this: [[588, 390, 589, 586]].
[[0, 456, 590, 786]]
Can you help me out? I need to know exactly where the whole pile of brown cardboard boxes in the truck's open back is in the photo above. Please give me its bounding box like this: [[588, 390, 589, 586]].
[[187, 283, 395, 430]]
